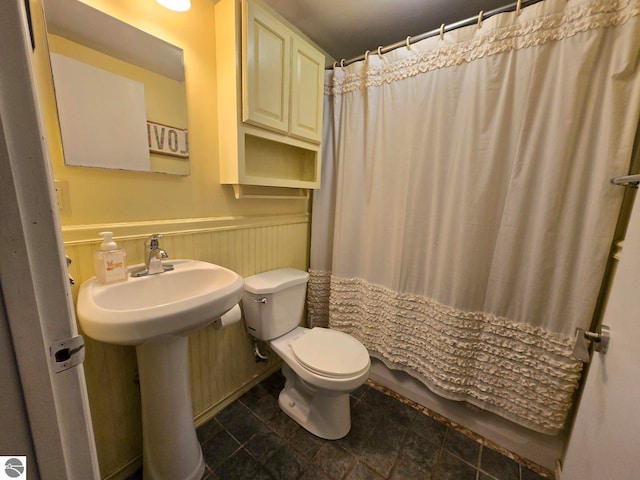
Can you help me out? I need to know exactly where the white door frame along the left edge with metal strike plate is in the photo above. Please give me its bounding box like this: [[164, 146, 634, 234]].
[[0, 0, 99, 480]]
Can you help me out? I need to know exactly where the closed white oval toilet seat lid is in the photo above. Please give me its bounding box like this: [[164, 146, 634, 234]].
[[290, 327, 370, 378]]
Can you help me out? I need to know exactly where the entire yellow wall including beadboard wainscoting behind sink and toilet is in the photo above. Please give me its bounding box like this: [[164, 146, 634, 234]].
[[31, 0, 320, 479]]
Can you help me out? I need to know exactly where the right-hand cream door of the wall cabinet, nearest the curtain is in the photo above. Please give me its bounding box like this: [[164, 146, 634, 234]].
[[289, 36, 324, 143]]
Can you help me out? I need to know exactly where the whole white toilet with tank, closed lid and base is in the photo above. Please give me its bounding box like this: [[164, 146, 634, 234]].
[[242, 268, 371, 440]]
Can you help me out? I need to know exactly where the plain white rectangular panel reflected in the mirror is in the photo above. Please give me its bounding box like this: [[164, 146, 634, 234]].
[[51, 53, 151, 172]]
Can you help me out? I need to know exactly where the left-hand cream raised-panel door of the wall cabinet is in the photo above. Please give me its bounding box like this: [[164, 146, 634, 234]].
[[242, 2, 291, 133]]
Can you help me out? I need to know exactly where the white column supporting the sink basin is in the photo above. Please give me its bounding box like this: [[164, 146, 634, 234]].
[[136, 335, 205, 480]]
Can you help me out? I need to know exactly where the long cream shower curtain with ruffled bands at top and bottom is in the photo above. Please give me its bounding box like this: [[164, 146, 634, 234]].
[[308, 0, 640, 434]]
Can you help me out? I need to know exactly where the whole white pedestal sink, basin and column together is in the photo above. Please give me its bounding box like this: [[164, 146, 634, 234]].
[[77, 260, 244, 480]]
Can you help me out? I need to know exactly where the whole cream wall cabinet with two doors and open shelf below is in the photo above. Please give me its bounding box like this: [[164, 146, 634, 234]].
[[215, 0, 325, 189]]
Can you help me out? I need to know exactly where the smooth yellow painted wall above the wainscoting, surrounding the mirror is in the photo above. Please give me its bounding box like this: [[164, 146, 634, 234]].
[[32, 0, 308, 226]]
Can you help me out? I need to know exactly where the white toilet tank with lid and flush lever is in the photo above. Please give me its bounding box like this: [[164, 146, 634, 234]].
[[242, 268, 309, 340]]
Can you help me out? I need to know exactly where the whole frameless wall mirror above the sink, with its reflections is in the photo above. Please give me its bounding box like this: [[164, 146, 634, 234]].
[[43, 0, 189, 175]]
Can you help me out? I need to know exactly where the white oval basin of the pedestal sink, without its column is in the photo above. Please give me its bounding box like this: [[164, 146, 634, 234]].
[[77, 260, 244, 345]]
